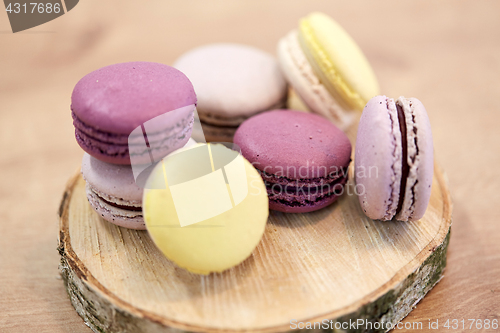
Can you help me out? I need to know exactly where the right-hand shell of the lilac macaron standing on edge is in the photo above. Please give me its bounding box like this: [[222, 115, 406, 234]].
[[396, 97, 434, 221]]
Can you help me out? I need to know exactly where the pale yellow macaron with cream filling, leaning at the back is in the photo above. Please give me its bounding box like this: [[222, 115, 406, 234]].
[[278, 12, 379, 130]]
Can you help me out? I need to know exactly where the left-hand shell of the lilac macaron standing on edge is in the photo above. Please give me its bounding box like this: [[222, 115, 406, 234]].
[[354, 96, 402, 220]]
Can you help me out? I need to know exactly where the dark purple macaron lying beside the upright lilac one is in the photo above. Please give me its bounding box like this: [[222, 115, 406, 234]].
[[234, 110, 352, 213]]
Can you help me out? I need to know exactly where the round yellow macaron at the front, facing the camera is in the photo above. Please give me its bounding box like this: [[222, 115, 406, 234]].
[[143, 143, 269, 274]]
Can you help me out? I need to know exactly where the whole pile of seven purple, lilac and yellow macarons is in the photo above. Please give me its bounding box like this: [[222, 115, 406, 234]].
[[71, 13, 433, 274]]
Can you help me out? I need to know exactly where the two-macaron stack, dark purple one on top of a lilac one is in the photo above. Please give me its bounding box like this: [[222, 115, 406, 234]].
[[71, 62, 196, 229]]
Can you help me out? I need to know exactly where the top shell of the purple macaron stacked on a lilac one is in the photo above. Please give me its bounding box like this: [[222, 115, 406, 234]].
[[71, 62, 196, 135]]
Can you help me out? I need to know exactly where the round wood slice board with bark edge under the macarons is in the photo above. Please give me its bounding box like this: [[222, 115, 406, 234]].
[[59, 166, 452, 332]]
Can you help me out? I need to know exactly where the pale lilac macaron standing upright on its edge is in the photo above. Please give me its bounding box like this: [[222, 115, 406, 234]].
[[355, 96, 434, 221]]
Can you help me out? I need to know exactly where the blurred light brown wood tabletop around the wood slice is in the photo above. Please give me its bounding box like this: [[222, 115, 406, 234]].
[[0, 0, 500, 333]]
